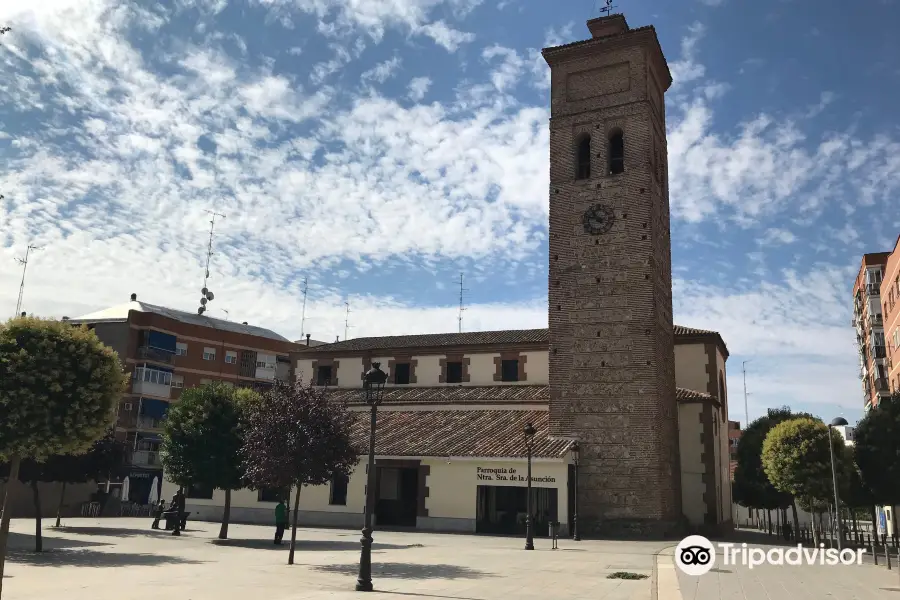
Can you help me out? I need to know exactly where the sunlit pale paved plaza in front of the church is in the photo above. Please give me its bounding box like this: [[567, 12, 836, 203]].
[[3, 519, 671, 600]]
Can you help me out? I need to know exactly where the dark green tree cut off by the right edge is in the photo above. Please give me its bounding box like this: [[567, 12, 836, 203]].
[[854, 392, 900, 531]]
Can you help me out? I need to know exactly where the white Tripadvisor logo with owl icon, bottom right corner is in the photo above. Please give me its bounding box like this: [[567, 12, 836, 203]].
[[675, 535, 866, 577]]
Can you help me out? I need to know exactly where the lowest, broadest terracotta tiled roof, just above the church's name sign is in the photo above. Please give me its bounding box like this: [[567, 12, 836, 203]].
[[353, 410, 571, 458]]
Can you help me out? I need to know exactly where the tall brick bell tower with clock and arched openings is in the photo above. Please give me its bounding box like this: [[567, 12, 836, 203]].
[[543, 14, 682, 535]]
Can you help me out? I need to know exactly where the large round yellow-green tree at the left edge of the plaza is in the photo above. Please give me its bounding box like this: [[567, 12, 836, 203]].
[[0, 317, 126, 593]]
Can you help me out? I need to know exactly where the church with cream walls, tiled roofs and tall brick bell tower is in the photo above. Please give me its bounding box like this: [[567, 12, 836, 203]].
[[164, 15, 733, 536]]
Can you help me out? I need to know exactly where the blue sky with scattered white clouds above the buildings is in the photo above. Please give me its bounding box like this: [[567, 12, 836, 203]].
[[0, 0, 900, 422]]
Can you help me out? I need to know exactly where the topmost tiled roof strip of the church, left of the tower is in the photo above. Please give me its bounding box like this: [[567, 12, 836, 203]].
[[317, 329, 550, 352]]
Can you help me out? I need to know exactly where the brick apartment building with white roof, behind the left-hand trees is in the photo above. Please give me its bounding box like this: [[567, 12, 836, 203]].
[[64, 294, 300, 504]]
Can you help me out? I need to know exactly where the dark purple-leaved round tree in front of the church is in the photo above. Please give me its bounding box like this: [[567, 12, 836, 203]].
[[242, 383, 361, 565]]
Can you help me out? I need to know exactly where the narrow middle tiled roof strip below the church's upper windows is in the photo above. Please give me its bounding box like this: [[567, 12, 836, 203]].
[[328, 385, 550, 405]]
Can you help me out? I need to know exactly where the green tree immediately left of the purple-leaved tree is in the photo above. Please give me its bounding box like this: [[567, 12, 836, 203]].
[[162, 382, 257, 540]]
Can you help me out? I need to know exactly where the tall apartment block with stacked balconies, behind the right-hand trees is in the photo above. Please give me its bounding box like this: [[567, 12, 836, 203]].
[[852, 252, 891, 411]]
